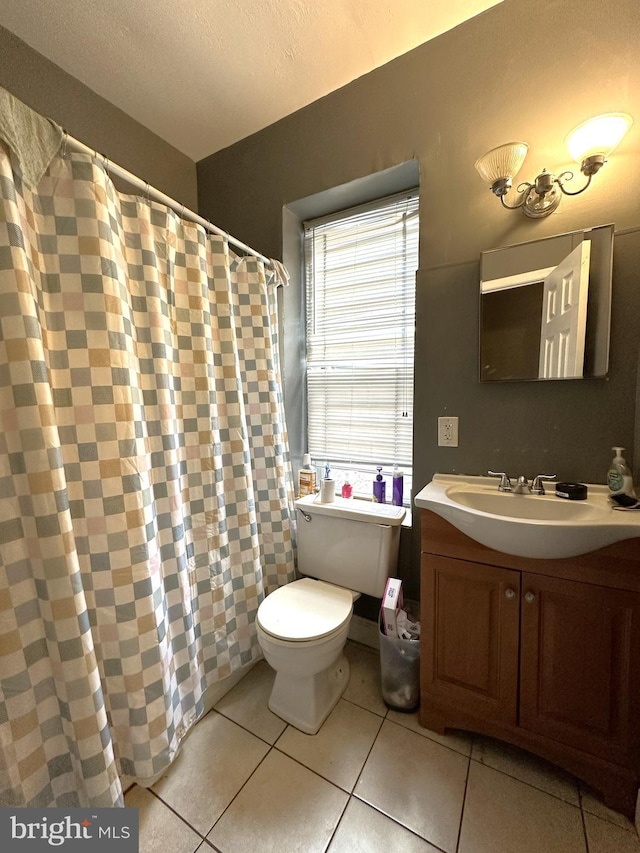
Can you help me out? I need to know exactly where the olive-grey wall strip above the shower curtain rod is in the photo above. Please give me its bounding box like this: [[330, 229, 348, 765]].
[[0, 24, 198, 210]]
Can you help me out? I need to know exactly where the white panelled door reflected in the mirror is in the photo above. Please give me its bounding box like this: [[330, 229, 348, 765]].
[[538, 240, 591, 379]]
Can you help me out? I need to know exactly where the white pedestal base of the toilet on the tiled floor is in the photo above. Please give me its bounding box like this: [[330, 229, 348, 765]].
[[269, 654, 349, 735]]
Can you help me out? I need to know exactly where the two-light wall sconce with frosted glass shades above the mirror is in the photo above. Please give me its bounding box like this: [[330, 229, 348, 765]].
[[476, 113, 633, 219]]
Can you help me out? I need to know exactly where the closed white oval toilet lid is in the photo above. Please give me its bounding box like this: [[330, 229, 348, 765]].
[[258, 578, 353, 641]]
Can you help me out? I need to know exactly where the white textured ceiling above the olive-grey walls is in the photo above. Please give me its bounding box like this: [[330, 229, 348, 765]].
[[0, 0, 501, 161]]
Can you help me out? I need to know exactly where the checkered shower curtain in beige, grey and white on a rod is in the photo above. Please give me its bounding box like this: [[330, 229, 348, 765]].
[[0, 144, 293, 807]]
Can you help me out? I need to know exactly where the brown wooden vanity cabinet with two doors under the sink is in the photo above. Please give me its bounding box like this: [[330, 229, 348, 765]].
[[420, 510, 640, 816]]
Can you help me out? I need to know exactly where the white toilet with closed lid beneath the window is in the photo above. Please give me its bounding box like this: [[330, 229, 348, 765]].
[[256, 495, 405, 734]]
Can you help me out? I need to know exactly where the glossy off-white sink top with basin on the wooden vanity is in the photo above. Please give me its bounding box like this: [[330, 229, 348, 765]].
[[415, 474, 640, 559]]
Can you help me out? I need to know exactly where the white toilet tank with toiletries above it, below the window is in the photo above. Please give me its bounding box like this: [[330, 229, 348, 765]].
[[295, 495, 406, 598]]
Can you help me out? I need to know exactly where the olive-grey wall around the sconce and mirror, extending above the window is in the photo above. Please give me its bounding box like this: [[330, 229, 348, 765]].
[[198, 0, 640, 591]]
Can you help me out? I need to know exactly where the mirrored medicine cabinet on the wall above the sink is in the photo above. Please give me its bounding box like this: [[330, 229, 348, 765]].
[[480, 225, 614, 382]]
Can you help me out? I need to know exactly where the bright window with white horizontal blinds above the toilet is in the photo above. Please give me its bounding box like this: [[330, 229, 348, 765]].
[[304, 191, 419, 503]]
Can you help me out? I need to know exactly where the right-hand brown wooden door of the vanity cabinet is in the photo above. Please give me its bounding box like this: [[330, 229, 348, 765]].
[[519, 573, 640, 767]]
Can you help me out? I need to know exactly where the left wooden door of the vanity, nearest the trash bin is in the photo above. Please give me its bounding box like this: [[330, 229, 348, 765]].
[[421, 554, 520, 723]]
